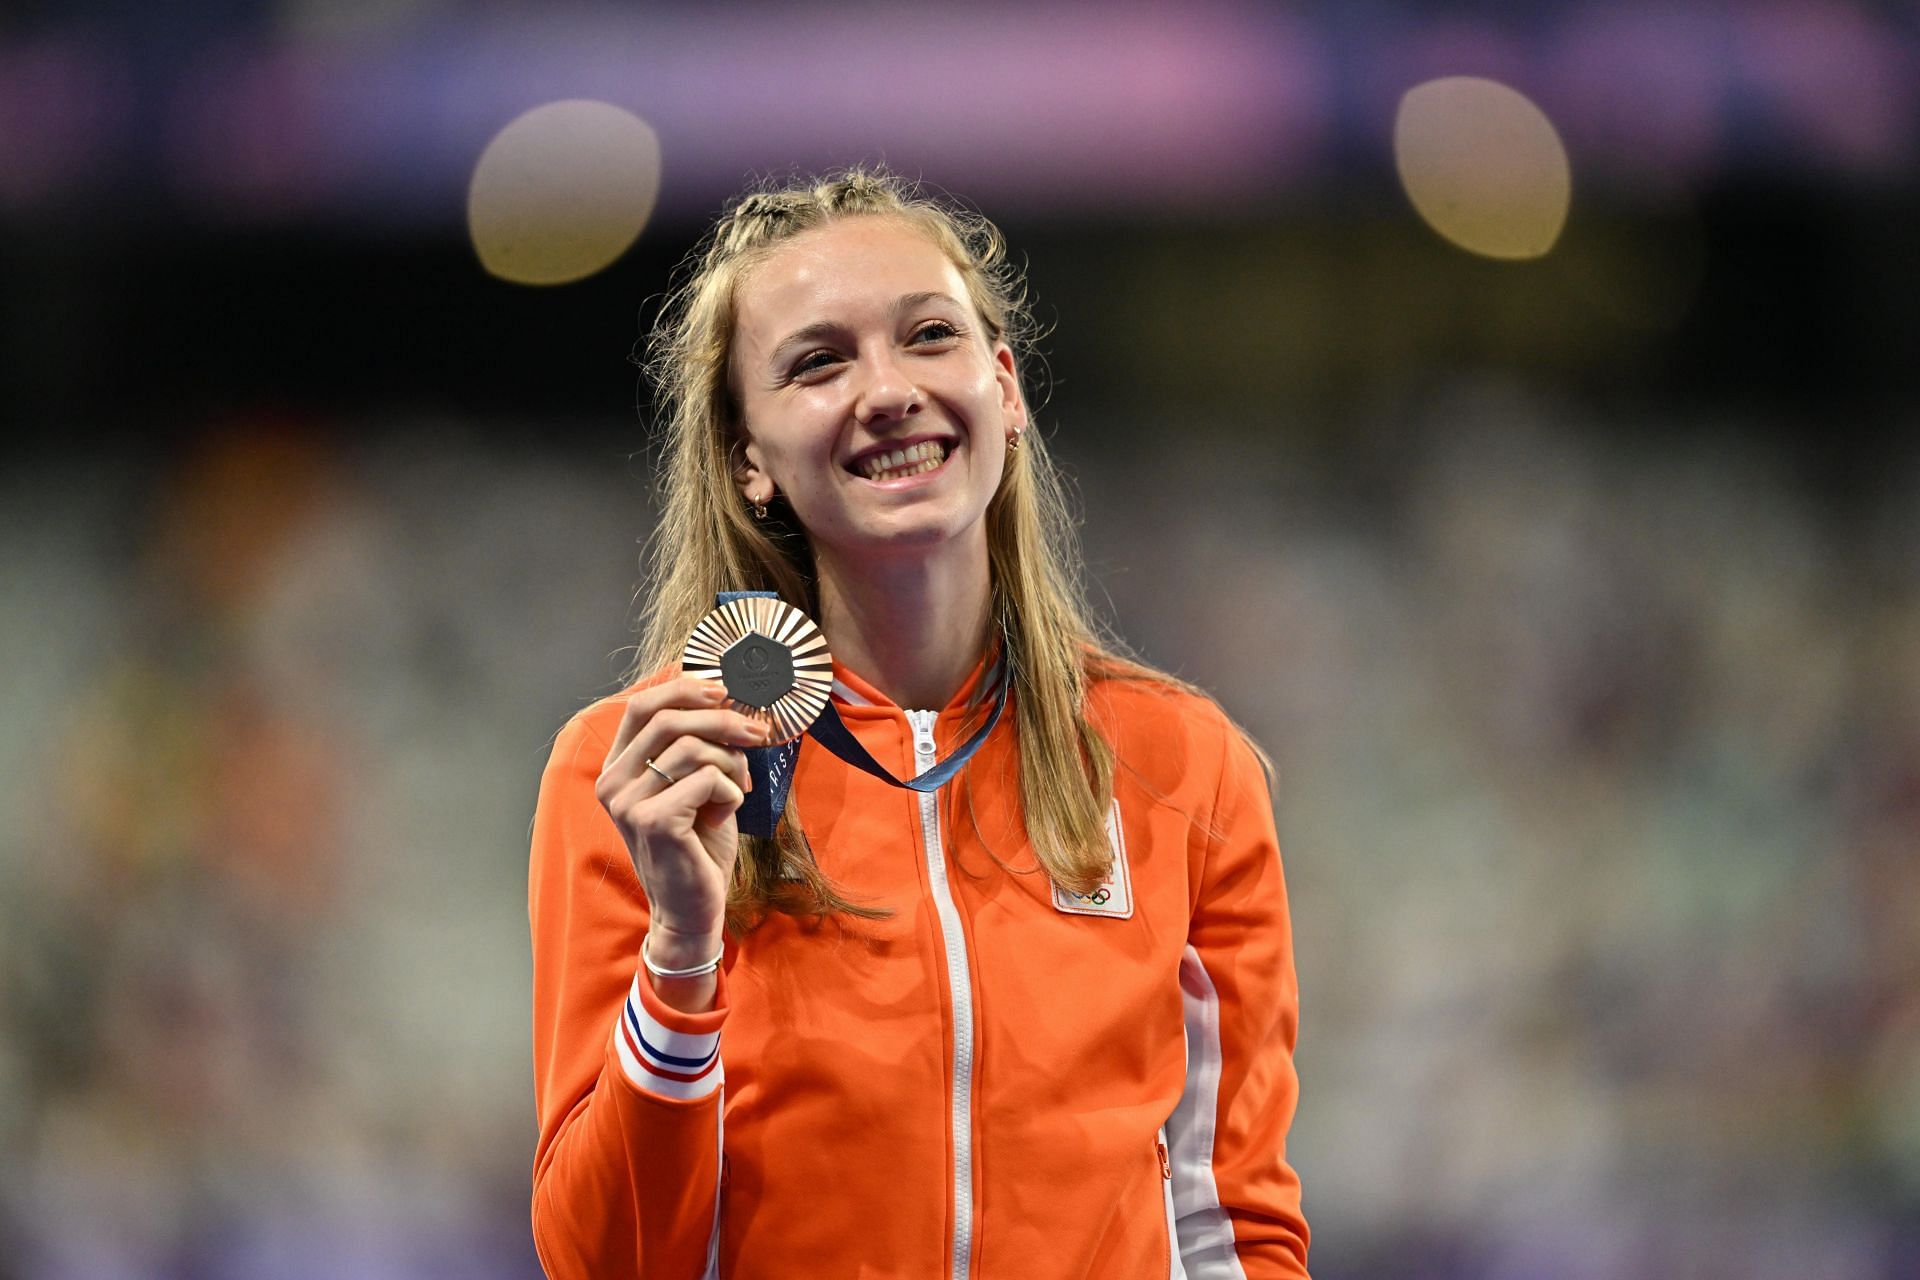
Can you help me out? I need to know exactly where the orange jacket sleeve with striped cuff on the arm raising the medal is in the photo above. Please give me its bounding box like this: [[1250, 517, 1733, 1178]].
[[528, 714, 726, 1280]]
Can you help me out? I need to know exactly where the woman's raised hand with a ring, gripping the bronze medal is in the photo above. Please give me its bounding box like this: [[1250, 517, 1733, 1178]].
[[593, 676, 768, 969]]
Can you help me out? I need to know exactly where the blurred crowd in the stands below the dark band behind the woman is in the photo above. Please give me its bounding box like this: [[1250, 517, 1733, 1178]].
[[0, 384, 1920, 1280]]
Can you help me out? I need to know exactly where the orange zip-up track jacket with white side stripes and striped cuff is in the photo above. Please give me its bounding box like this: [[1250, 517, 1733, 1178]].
[[528, 664, 1308, 1280]]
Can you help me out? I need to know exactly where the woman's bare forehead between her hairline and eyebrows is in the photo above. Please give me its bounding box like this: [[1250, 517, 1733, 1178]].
[[733, 215, 968, 345]]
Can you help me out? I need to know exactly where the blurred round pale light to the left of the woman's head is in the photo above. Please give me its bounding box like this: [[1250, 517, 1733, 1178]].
[[467, 100, 660, 284]]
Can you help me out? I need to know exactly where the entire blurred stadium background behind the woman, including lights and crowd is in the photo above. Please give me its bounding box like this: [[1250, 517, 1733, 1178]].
[[0, 0, 1920, 1280]]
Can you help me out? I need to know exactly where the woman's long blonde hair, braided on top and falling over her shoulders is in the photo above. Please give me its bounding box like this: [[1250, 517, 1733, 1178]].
[[630, 167, 1273, 933]]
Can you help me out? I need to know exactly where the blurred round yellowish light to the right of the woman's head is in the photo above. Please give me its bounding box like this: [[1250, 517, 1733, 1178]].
[[1394, 75, 1572, 259]]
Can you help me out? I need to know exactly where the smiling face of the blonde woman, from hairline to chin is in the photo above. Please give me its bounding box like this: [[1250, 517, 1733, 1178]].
[[730, 215, 1027, 558]]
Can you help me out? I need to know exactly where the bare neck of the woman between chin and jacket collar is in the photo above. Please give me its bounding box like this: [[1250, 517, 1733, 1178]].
[[814, 528, 993, 710]]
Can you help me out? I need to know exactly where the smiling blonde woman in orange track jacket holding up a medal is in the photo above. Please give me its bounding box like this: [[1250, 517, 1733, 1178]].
[[530, 171, 1308, 1280]]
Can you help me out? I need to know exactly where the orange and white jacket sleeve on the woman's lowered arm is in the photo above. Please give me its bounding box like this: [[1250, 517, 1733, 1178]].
[[1167, 723, 1308, 1280]]
